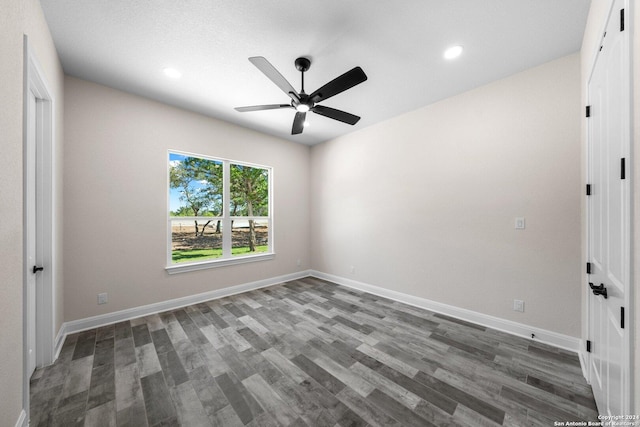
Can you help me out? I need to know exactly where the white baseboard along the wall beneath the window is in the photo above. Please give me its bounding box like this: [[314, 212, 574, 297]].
[[55, 270, 311, 344]]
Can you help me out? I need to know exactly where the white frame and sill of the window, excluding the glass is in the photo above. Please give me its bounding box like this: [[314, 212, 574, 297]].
[[165, 150, 275, 274]]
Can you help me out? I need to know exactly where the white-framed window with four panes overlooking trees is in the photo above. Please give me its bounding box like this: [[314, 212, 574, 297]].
[[167, 152, 273, 273]]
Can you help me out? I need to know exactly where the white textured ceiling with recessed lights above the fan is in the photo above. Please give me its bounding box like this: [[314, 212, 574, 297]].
[[41, 0, 590, 145]]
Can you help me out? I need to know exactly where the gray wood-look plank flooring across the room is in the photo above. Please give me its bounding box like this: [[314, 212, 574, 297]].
[[31, 278, 597, 427]]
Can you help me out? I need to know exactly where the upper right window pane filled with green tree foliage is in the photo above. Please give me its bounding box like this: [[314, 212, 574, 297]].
[[230, 164, 269, 216]]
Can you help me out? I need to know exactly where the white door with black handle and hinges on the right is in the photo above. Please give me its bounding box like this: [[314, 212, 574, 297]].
[[587, 0, 631, 415]]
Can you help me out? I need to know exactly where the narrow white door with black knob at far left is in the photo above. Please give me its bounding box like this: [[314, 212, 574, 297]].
[[25, 91, 38, 376]]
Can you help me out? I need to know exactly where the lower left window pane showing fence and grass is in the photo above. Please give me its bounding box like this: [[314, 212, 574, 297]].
[[171, 219, 222, 264]]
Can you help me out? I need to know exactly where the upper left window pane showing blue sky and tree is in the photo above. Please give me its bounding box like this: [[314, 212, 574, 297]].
[[169, 153, 222, 216]]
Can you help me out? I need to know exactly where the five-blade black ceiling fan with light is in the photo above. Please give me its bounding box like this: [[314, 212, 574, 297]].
[[236, 56, 367, 135]]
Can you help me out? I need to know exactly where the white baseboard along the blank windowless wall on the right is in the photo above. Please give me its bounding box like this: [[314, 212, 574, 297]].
[[310, 270, 584, 358]]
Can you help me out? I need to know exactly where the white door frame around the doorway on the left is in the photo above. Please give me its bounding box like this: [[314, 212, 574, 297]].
[[22, 35, 56, 419]]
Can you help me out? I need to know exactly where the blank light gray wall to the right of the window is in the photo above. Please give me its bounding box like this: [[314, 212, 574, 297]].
[[311, 54, 582, 337]]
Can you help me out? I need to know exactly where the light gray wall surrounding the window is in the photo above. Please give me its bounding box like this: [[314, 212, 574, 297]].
[[64, 77, 310, 321]]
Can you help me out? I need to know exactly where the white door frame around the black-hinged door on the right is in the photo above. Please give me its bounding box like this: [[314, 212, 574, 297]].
[[583, 0, 637, 414]]
